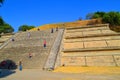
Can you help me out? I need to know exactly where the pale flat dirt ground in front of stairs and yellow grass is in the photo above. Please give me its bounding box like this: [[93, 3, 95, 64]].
[[0, 69, 120, 80]]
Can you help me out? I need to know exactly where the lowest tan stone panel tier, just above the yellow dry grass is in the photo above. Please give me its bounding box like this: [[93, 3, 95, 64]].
[[61, 54, 120, 66]]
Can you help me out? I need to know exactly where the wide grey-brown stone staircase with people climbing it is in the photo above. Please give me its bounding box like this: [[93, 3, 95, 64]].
[[0, 30, 58, 69]]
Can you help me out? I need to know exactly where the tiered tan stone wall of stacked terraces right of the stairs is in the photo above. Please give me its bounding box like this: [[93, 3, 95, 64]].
[[60, 24, 120, 66]]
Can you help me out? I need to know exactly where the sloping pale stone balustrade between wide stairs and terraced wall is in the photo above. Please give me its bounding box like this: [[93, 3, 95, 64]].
[[44, 29, 63, 70]]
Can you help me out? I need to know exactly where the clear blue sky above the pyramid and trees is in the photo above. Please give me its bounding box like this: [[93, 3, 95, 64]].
[[0, 0, 120, 32]]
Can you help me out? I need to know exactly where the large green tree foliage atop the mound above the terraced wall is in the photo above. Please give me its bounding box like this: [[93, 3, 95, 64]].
[[86, 11, 120, 26]]
